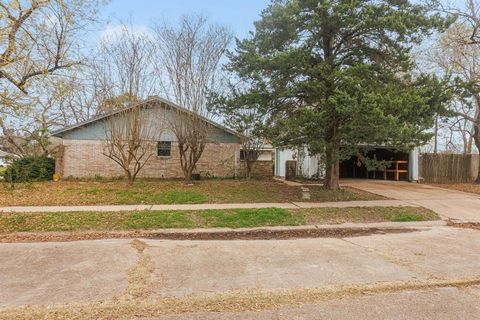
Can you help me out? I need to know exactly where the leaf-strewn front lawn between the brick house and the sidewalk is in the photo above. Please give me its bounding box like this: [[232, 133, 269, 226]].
[[0, 179, 384, 206]]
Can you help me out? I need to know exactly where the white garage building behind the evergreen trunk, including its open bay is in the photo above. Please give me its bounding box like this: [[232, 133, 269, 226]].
[[275, 146, 420, 181]]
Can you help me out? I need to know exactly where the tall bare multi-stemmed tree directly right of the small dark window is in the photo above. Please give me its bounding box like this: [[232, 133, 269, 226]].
[[154, 16, 232, 181]]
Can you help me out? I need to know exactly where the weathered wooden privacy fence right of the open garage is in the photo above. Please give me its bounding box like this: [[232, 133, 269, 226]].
[[419, 153, 479, 183]]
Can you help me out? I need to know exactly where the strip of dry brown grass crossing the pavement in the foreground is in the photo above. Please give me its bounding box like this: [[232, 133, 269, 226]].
[[0, 278, 480, 320]]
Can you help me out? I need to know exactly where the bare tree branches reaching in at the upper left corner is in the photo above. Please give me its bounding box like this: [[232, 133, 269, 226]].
[[0, 0, 97, 106]]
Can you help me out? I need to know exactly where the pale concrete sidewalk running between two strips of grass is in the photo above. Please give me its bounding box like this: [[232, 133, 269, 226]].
[[0, 200, 418, 212]]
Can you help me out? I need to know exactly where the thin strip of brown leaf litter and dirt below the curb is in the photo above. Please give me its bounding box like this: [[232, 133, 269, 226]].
[[0, 228, 420, 243]]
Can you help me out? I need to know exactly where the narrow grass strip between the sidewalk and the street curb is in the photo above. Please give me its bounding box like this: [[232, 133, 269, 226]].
[[0, 207, 439, 234]]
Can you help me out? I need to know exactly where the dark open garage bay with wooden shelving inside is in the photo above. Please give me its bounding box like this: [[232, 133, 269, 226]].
[[340, 147, 418, 181]]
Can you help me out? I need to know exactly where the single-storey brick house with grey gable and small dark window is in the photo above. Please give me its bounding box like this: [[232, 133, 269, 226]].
[[52, 97, 244, 178]]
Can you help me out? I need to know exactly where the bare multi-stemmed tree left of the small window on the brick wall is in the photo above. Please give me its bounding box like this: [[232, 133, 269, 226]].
[[94, 25, 164, 185]]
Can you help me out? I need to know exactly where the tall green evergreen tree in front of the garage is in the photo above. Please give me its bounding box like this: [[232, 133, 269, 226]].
[[228, 0, 450, 189]]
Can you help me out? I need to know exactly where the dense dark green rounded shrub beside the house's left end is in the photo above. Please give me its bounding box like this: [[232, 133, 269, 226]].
[[3, 156, 55, 182]]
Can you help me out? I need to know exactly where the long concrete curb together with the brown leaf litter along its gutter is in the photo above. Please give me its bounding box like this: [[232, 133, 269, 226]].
[[0, 221, 446, 243]]
